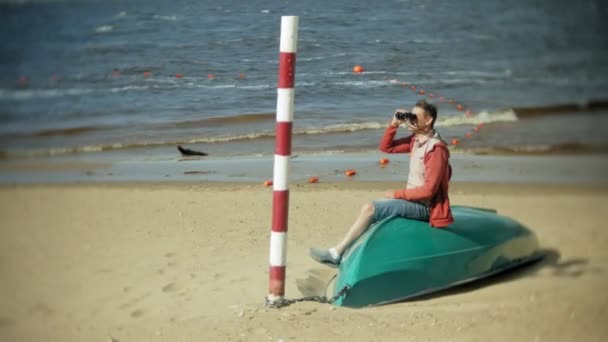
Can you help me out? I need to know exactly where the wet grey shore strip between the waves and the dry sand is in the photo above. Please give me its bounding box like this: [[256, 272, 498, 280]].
[[0, 152, 608, 184]]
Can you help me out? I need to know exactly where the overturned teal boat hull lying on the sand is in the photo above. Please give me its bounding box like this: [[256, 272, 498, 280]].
[[333, 206, 542, 308]]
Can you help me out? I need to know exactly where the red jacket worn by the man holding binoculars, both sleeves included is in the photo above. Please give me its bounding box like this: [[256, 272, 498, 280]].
[[380, 126, 454, 228]]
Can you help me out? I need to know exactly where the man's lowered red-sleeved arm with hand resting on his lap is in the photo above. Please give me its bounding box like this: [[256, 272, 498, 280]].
[[393, 145, 449, 201]]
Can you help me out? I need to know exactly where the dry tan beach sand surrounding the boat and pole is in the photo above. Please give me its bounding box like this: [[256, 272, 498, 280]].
[[0, 181, 608, 342]]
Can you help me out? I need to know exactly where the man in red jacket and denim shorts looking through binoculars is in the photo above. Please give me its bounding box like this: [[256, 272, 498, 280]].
[[310, 100, 454, 266]]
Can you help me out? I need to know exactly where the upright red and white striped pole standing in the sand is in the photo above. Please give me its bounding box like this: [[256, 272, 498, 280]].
[[266, 16, 298, 306]]
